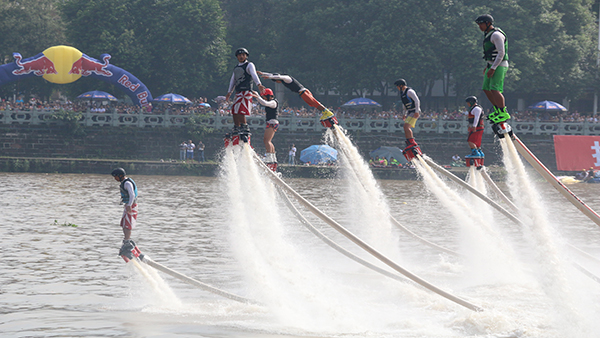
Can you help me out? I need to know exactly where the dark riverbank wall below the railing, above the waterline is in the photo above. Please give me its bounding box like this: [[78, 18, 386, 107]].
[[0, 125, 556, 178]]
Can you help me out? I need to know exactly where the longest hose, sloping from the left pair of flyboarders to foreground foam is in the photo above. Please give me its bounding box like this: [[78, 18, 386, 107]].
[[251, 147, 483, 312]]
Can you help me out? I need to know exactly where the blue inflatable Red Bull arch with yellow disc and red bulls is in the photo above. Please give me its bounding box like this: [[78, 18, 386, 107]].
[[0, 46, 152, 107]]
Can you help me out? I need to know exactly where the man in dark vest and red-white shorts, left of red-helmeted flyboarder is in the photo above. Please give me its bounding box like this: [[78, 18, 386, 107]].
[[225, 48, 265, 142]]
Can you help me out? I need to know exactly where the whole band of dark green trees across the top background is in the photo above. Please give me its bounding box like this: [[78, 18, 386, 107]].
[[0, 0, 598, 108]]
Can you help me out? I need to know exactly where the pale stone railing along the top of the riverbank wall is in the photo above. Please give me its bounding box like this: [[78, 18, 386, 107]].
[[0, 110, 600, 135]]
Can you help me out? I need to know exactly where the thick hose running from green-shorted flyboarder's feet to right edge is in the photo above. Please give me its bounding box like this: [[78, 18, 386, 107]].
[[507, 135, 600, 226]]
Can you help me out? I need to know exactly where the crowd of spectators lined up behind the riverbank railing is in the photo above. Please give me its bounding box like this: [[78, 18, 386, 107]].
[[0, 96, 598, 123]]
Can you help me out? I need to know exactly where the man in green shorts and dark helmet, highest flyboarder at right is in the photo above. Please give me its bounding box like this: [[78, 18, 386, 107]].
[[475, 14, 510, 136]]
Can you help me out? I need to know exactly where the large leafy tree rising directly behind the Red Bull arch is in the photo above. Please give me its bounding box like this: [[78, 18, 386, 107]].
[[62, 0, 229, 97]]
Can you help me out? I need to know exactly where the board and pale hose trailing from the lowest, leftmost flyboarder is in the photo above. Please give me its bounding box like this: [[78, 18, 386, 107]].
[[121, 240, 258, 304]]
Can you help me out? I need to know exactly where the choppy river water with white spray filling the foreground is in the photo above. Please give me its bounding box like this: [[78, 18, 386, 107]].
[[0, 149, 600, 338]]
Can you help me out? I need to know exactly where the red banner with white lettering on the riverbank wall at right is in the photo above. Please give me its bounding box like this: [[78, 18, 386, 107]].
[[554, 135, 600, 171]]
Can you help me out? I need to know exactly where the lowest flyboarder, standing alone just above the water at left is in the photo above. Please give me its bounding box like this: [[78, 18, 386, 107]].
[[111, 168, 138, 259]]
